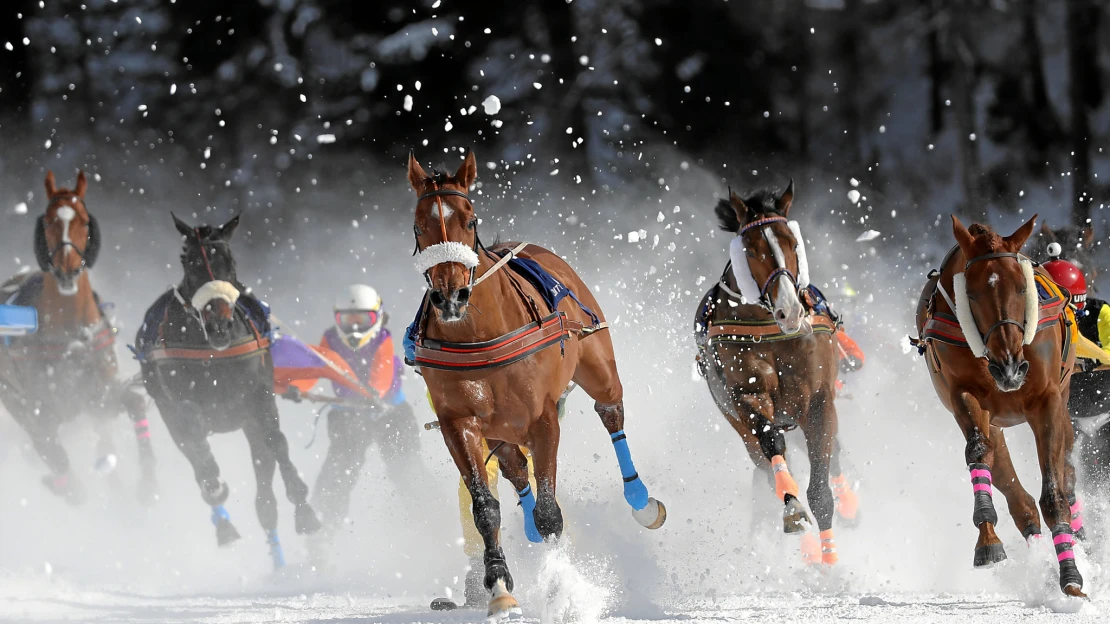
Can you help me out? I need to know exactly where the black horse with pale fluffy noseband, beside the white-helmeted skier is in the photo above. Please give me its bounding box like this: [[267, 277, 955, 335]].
[[135, 210, 321, 568]]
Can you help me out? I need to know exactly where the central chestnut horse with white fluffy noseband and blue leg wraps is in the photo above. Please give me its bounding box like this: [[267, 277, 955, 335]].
[[406, 147, 666, 616]]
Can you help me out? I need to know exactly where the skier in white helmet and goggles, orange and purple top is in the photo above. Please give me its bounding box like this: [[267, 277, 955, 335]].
[[313, 284, 427, 529]]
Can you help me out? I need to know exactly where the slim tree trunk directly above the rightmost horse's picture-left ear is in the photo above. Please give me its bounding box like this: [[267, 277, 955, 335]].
[[949, 26, 987, 223]]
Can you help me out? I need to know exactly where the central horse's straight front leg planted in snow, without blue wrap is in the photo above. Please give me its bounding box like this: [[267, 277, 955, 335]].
[[440, 414, 521, 616]]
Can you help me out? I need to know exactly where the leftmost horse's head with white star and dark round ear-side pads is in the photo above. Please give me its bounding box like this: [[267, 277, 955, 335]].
[[34, 171, 100, 295]]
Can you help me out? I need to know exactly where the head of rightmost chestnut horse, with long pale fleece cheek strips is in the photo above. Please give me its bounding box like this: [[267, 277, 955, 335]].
[[952, 214, 1038, 392]]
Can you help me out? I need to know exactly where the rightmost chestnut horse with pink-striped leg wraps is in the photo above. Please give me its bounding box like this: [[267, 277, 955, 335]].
[[917, 215, 1083, 596]]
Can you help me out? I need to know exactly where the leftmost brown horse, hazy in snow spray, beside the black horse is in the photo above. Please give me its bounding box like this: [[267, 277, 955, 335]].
[[0, 171, 157, 503]]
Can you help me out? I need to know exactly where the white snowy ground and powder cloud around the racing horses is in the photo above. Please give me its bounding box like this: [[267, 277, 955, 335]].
[[0, 170, 1110, 623]]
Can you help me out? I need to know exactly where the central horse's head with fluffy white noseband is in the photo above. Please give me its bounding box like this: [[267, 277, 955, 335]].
[[408, 151, 478, 322]]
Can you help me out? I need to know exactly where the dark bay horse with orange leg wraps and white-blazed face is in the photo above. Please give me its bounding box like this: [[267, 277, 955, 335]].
[[695, 182, 855, 565]]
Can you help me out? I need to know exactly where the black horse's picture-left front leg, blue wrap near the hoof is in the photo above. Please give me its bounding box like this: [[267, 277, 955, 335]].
[[159, 402, 240, 546]]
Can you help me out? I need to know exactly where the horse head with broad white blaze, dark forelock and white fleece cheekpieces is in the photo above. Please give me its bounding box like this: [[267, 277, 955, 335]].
[[716, 180, 809, 333]]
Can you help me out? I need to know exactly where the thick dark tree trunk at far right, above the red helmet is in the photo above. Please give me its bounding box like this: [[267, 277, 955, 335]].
[[1067, 0, 1102, 225]]
